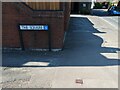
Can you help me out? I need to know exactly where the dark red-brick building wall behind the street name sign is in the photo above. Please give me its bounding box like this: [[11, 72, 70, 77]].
[[2, 2, 69, 49]]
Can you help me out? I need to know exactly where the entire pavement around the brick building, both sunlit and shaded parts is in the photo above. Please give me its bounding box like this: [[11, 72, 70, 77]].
[[1, 15, 120, 88]]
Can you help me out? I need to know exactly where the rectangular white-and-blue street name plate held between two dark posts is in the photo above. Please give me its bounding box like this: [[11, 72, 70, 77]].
[[20, 25, 48, 30]]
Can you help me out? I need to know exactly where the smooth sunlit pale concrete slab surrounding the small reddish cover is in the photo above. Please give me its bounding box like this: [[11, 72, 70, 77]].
[[52, 67, 118, 88]]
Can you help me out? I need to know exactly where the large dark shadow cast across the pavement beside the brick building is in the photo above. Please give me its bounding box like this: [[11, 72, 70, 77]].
[[2, 17, 119, 67]]
